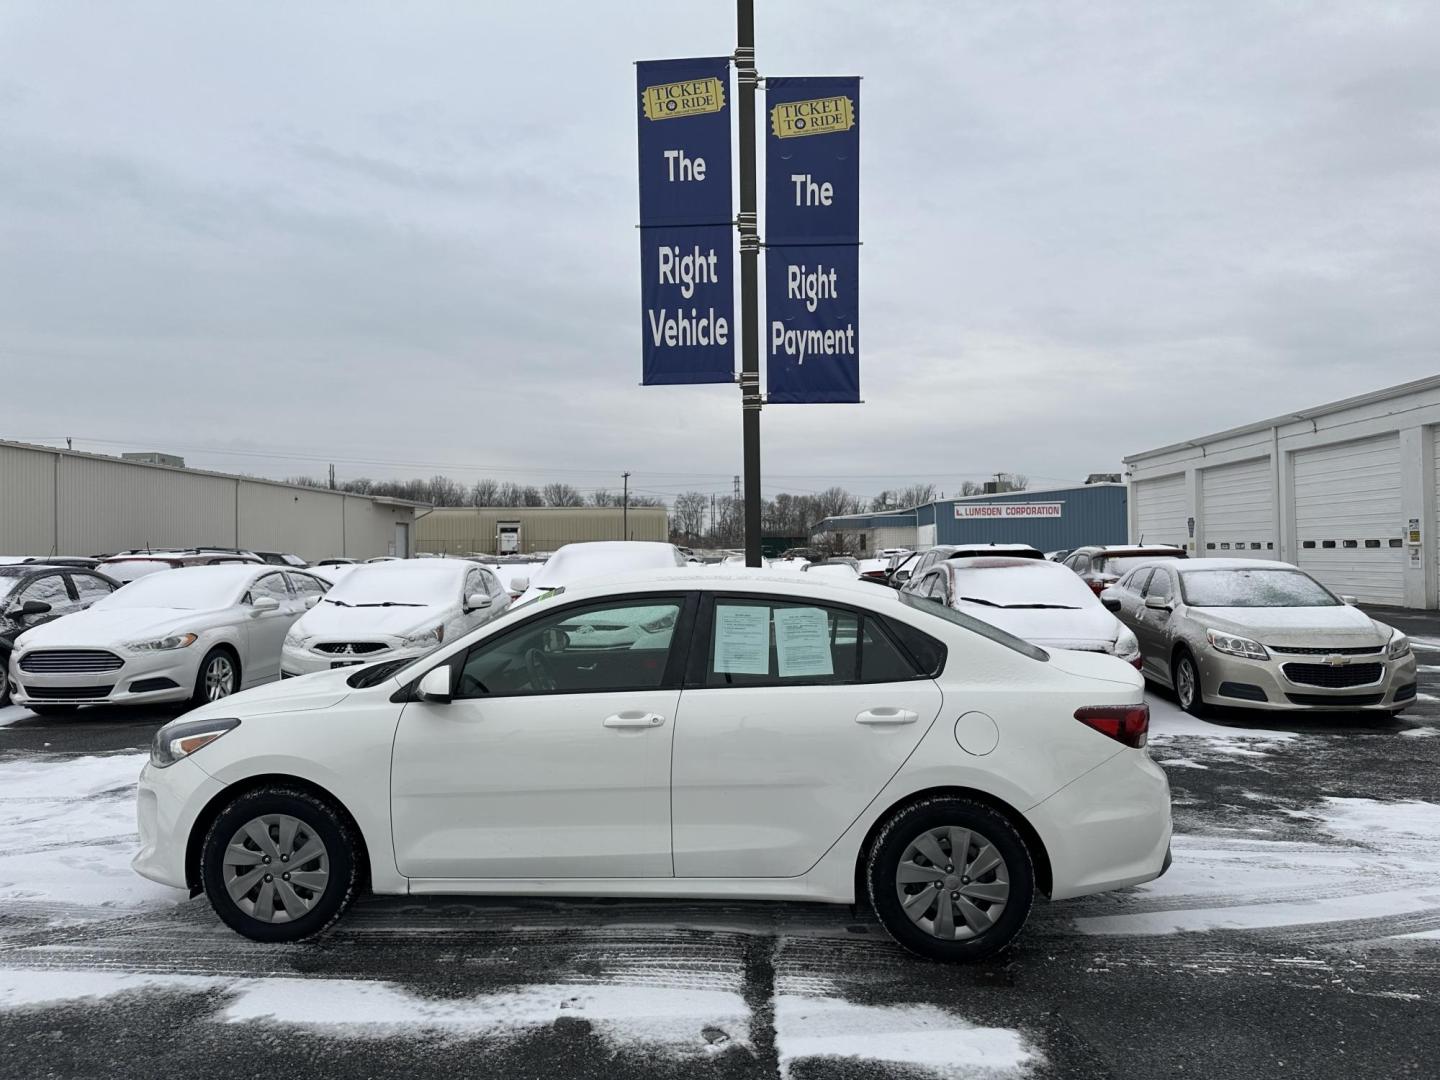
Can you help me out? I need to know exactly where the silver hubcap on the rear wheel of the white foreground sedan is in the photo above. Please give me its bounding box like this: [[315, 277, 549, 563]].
[[896, 825, 1009, 942]]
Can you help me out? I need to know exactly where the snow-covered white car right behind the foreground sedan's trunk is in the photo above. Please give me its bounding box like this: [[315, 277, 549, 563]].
[[904, 556, 1140, 668]]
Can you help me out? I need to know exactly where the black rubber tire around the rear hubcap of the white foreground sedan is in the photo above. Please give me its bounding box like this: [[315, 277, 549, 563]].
[[865, 796, 1035, 962]]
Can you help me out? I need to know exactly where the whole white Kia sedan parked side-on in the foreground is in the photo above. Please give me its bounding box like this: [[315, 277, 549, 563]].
[[134, 570, 1171, 960]]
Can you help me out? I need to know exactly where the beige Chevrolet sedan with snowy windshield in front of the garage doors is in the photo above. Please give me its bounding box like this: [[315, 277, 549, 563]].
[[1102, 559, 1416, 716]]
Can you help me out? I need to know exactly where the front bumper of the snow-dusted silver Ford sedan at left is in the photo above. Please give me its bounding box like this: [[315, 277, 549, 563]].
[[10, 642, 204, 706]]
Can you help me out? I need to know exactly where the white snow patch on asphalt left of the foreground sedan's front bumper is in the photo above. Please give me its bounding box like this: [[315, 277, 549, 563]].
[[0, 755, 184, 923]]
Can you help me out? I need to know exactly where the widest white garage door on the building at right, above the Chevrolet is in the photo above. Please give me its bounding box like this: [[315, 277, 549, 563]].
[[1295, 435, 1405, 603]]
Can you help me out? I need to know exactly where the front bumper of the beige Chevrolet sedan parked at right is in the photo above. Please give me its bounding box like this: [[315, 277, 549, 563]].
[[1197, 648, 1416, 713]]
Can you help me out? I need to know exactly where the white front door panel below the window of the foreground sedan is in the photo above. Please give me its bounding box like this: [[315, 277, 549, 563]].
[[392, 690, 680, 878]]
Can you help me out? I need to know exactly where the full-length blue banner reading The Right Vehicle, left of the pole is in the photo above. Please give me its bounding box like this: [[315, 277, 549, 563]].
[[635, 58, 734, 386]]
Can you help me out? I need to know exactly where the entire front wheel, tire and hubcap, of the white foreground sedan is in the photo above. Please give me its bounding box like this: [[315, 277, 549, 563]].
[[200, 788, 360, 942]]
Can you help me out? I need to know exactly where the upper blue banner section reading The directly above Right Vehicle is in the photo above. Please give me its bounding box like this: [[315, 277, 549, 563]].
[[635, 58, 734, 226]]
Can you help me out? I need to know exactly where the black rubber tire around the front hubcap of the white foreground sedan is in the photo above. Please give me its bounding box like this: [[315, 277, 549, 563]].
[[200, 786, 360, 942]]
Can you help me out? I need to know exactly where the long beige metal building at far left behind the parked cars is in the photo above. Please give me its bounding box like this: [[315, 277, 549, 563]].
[[0, 441, 423, 560]]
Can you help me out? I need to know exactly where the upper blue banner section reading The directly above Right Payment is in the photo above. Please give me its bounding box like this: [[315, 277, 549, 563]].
[[765, 78, 860, 245]]
